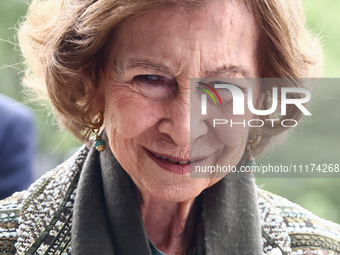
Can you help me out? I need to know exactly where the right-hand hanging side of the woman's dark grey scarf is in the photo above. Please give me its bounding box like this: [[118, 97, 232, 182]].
[[203, 169, 262, 255]]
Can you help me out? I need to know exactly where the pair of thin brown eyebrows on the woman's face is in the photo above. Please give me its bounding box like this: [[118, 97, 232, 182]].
[[126, 58, 250, 78]]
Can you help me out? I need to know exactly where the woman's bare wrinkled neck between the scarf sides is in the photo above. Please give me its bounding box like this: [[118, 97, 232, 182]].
[[141, 194, 197, 254]]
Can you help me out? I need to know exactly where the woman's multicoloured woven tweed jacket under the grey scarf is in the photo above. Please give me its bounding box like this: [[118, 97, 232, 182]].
[[0, 147, 340, 255]]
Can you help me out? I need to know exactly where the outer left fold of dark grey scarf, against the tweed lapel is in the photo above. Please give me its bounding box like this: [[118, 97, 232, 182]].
[[72, 146, 114, 254]]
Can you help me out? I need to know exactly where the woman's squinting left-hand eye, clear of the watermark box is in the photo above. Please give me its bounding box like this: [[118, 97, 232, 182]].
[[133, 74, 177, 100]]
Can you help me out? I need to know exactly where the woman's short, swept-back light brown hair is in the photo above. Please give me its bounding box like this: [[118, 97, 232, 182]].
[[19, 0, 322, 154]]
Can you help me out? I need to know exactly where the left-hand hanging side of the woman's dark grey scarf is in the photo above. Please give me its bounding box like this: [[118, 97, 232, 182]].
[[72, 145, 151, 255]]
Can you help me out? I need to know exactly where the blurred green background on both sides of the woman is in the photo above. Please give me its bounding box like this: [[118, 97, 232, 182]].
[[0, 0, 340, 223]]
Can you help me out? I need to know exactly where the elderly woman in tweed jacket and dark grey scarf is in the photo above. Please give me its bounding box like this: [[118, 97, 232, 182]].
[[0, 0, 340, 255]]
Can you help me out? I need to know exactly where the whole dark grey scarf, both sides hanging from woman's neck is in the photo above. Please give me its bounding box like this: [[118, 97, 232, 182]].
[[72, 140, 262, 255]]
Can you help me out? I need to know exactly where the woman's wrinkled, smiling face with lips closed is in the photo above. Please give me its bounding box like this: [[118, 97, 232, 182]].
[[100, 1, 258, 202]]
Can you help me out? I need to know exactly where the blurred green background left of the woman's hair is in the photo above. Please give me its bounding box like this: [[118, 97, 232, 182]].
[[0, 0, 79, 176]]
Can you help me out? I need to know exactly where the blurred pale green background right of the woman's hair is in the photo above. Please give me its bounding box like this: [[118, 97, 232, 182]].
[[257, 0, 340, 223]]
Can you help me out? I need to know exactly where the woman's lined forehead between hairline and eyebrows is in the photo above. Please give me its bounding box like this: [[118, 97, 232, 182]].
[[113, 1, 257, 76]]
